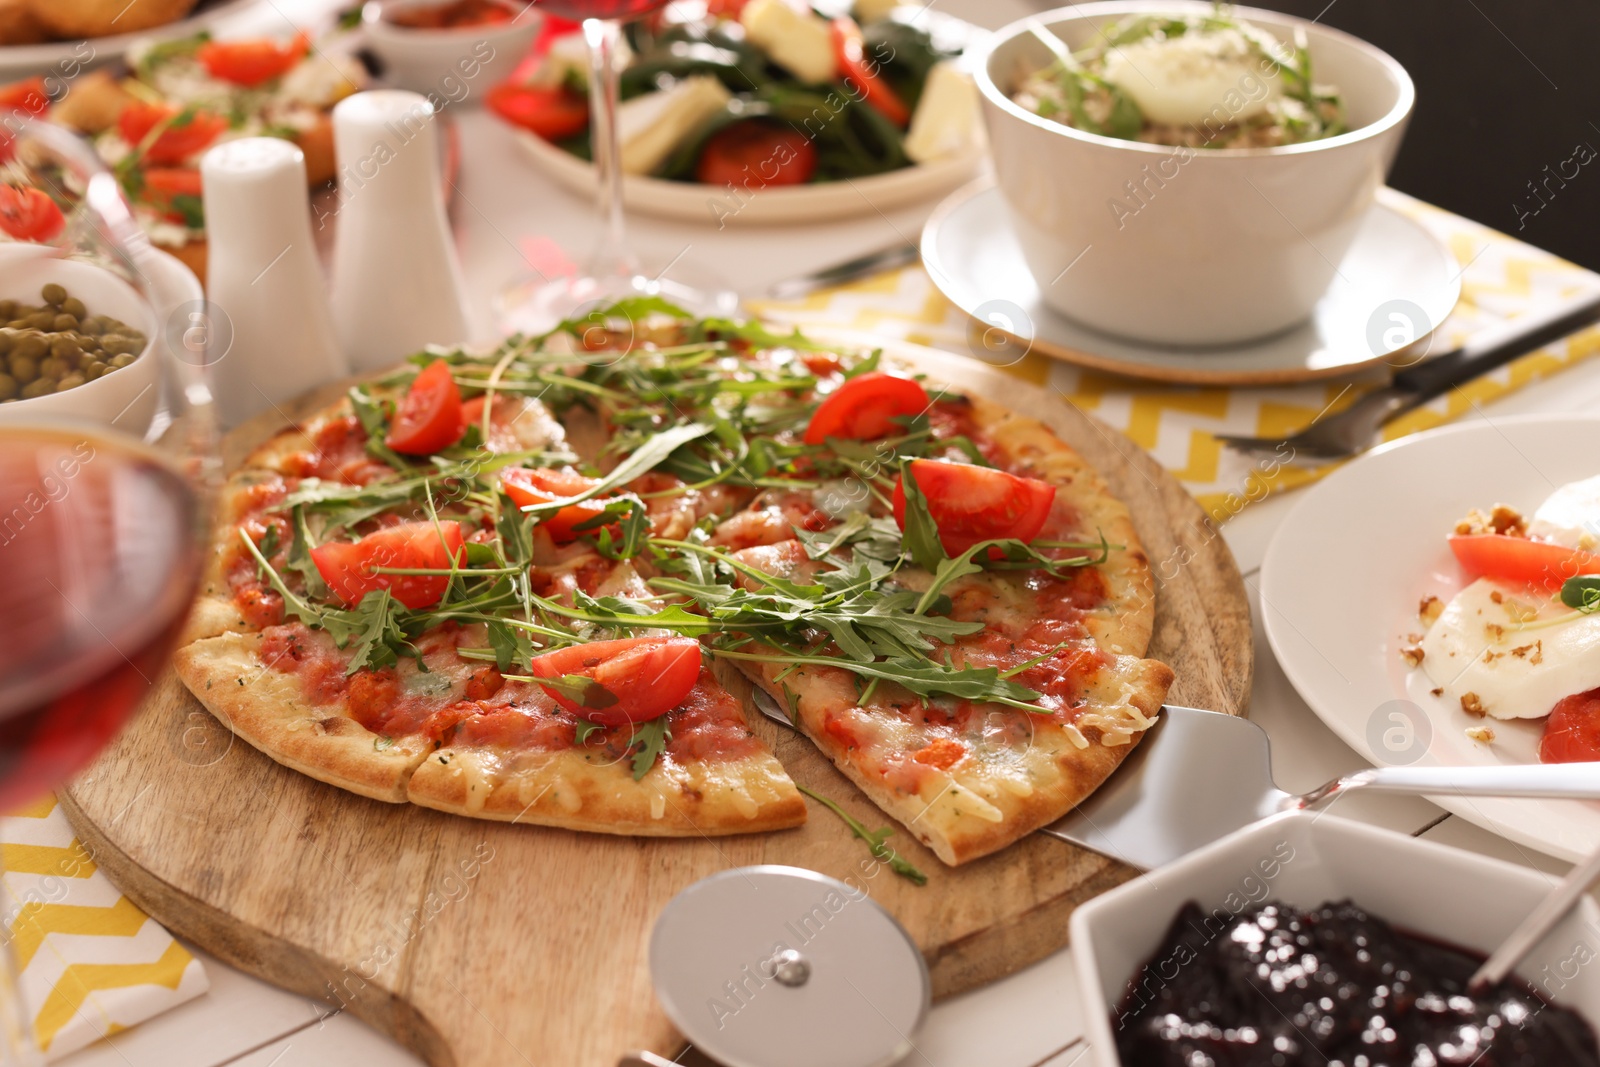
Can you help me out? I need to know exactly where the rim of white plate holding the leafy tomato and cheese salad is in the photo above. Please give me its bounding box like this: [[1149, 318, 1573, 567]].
[[517, 131, 984, 229]]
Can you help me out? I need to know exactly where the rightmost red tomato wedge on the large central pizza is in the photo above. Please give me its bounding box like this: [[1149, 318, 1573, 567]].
[[893, 459, 1056, 557]]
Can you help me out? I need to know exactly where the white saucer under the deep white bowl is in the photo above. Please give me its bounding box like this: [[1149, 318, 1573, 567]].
[[922, 179, 1461, 386]]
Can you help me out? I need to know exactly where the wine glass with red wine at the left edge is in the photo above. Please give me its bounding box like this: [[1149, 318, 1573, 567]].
[[0, 112, 218, 1065]]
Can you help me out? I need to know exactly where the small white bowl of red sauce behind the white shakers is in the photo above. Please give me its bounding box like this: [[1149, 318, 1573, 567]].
[[362, 0, 544, 101]]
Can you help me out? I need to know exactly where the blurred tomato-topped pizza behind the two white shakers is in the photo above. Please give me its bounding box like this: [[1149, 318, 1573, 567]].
[[39, 32, 368, 280]]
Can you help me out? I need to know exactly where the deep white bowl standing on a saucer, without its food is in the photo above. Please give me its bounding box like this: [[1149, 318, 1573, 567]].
[[978, 0, 1416, 346]]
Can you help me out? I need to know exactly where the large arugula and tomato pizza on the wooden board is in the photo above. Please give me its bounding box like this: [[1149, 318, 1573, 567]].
[[176, 299, 1173, 864]]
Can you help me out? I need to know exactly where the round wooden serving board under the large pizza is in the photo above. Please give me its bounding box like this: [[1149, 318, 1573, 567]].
[[62, 337, 1251, 1067]]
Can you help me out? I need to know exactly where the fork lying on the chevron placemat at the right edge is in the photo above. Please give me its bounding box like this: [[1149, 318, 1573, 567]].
[[1216, 293, 1600, 461]]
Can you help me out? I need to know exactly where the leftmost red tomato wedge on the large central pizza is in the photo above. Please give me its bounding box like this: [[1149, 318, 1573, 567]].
[[310, 522, 466, 609]]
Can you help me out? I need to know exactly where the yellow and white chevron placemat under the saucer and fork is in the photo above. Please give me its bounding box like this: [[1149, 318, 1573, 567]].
[[755, 189, 1600, 522]]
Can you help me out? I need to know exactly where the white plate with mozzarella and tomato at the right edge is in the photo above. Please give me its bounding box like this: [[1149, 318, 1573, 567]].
[[1261, 416, 1600, 861]]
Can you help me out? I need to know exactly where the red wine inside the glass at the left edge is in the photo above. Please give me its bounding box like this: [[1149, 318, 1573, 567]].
[[0, 429, 202, 813]]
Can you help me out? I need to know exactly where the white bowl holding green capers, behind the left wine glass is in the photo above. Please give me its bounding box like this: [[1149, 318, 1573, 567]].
[[0, 243, 164, 437]]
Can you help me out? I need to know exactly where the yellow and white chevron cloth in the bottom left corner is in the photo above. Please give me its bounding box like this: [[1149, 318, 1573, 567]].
[[0, 797, 210, 1061]]
